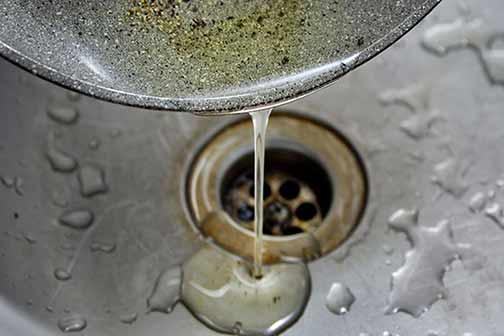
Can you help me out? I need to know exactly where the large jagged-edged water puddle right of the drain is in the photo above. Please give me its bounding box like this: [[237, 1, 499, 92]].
[[385, 209, 469, 317]]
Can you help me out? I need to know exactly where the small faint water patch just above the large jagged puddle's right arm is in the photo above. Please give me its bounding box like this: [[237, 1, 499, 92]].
[[433, 158, 469, 198]]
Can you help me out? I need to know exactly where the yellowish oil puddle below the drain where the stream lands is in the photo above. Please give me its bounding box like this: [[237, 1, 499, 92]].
[[182, 246, 311, 335]]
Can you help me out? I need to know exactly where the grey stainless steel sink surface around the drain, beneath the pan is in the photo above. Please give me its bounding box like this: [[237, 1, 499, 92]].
[[0, 0, 504, 336]]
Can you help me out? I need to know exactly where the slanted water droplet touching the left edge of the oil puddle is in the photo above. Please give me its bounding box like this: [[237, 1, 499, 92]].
[[147, 267, 182, 313]]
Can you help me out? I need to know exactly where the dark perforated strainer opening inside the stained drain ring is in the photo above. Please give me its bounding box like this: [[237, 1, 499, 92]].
[[221, 148, 332, 236]]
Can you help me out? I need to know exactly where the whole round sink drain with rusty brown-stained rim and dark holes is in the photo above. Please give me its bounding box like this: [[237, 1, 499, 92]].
[[184, 113, 367, 262]]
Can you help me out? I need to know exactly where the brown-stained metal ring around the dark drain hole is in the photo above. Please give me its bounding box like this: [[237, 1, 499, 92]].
[[186, 114, 367, 263]]
